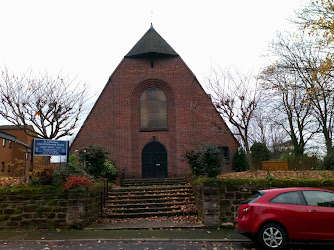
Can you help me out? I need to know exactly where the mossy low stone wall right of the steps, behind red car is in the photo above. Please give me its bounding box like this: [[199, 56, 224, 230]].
[[193, 178, 334, 228]]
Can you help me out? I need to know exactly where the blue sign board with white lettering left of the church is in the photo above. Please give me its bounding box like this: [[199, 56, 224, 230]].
[[33, 139, 68, 156]]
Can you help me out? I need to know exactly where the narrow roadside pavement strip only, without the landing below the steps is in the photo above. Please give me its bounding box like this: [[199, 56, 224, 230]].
[[0, 228, 248, 242]]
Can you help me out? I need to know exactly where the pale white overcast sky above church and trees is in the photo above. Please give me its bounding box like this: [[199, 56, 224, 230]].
[[0, 0, 308, 126]]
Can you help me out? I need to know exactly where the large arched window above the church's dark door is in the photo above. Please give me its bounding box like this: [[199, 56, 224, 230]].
[[140, 88, 168, 130]]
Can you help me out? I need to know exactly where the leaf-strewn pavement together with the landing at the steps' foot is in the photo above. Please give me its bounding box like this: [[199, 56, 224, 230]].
[[0, 216, 249, 242]]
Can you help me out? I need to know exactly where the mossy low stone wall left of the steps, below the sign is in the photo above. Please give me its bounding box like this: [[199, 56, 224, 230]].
[[0, 186, 101, 229]]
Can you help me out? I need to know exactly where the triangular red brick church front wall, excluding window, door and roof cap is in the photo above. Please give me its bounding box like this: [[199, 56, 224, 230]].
[[71, 28, 238, 178]]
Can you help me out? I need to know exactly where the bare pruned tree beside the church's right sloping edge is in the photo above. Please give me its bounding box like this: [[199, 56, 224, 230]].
[[207, 69, 263, 169]]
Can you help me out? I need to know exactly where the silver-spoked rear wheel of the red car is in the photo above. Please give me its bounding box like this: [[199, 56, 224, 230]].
[[258, 224, 286, 249]]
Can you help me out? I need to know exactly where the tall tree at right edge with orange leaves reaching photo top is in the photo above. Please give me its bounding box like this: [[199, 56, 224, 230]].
[[276, 0, 334, 155]]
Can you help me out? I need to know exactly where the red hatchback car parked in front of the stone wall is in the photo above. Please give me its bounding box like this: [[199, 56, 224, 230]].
[[235, 188, 334, 249]]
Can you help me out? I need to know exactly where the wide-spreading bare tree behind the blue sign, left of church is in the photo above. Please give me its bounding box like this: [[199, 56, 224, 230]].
[[0, 69, 89, 139]]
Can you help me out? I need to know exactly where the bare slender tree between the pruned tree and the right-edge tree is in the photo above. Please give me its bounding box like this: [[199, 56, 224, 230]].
[[261, 63, 318, 156]]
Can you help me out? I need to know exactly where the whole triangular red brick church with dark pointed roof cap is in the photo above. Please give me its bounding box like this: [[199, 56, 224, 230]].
[[71, 25, 238, 178]]
